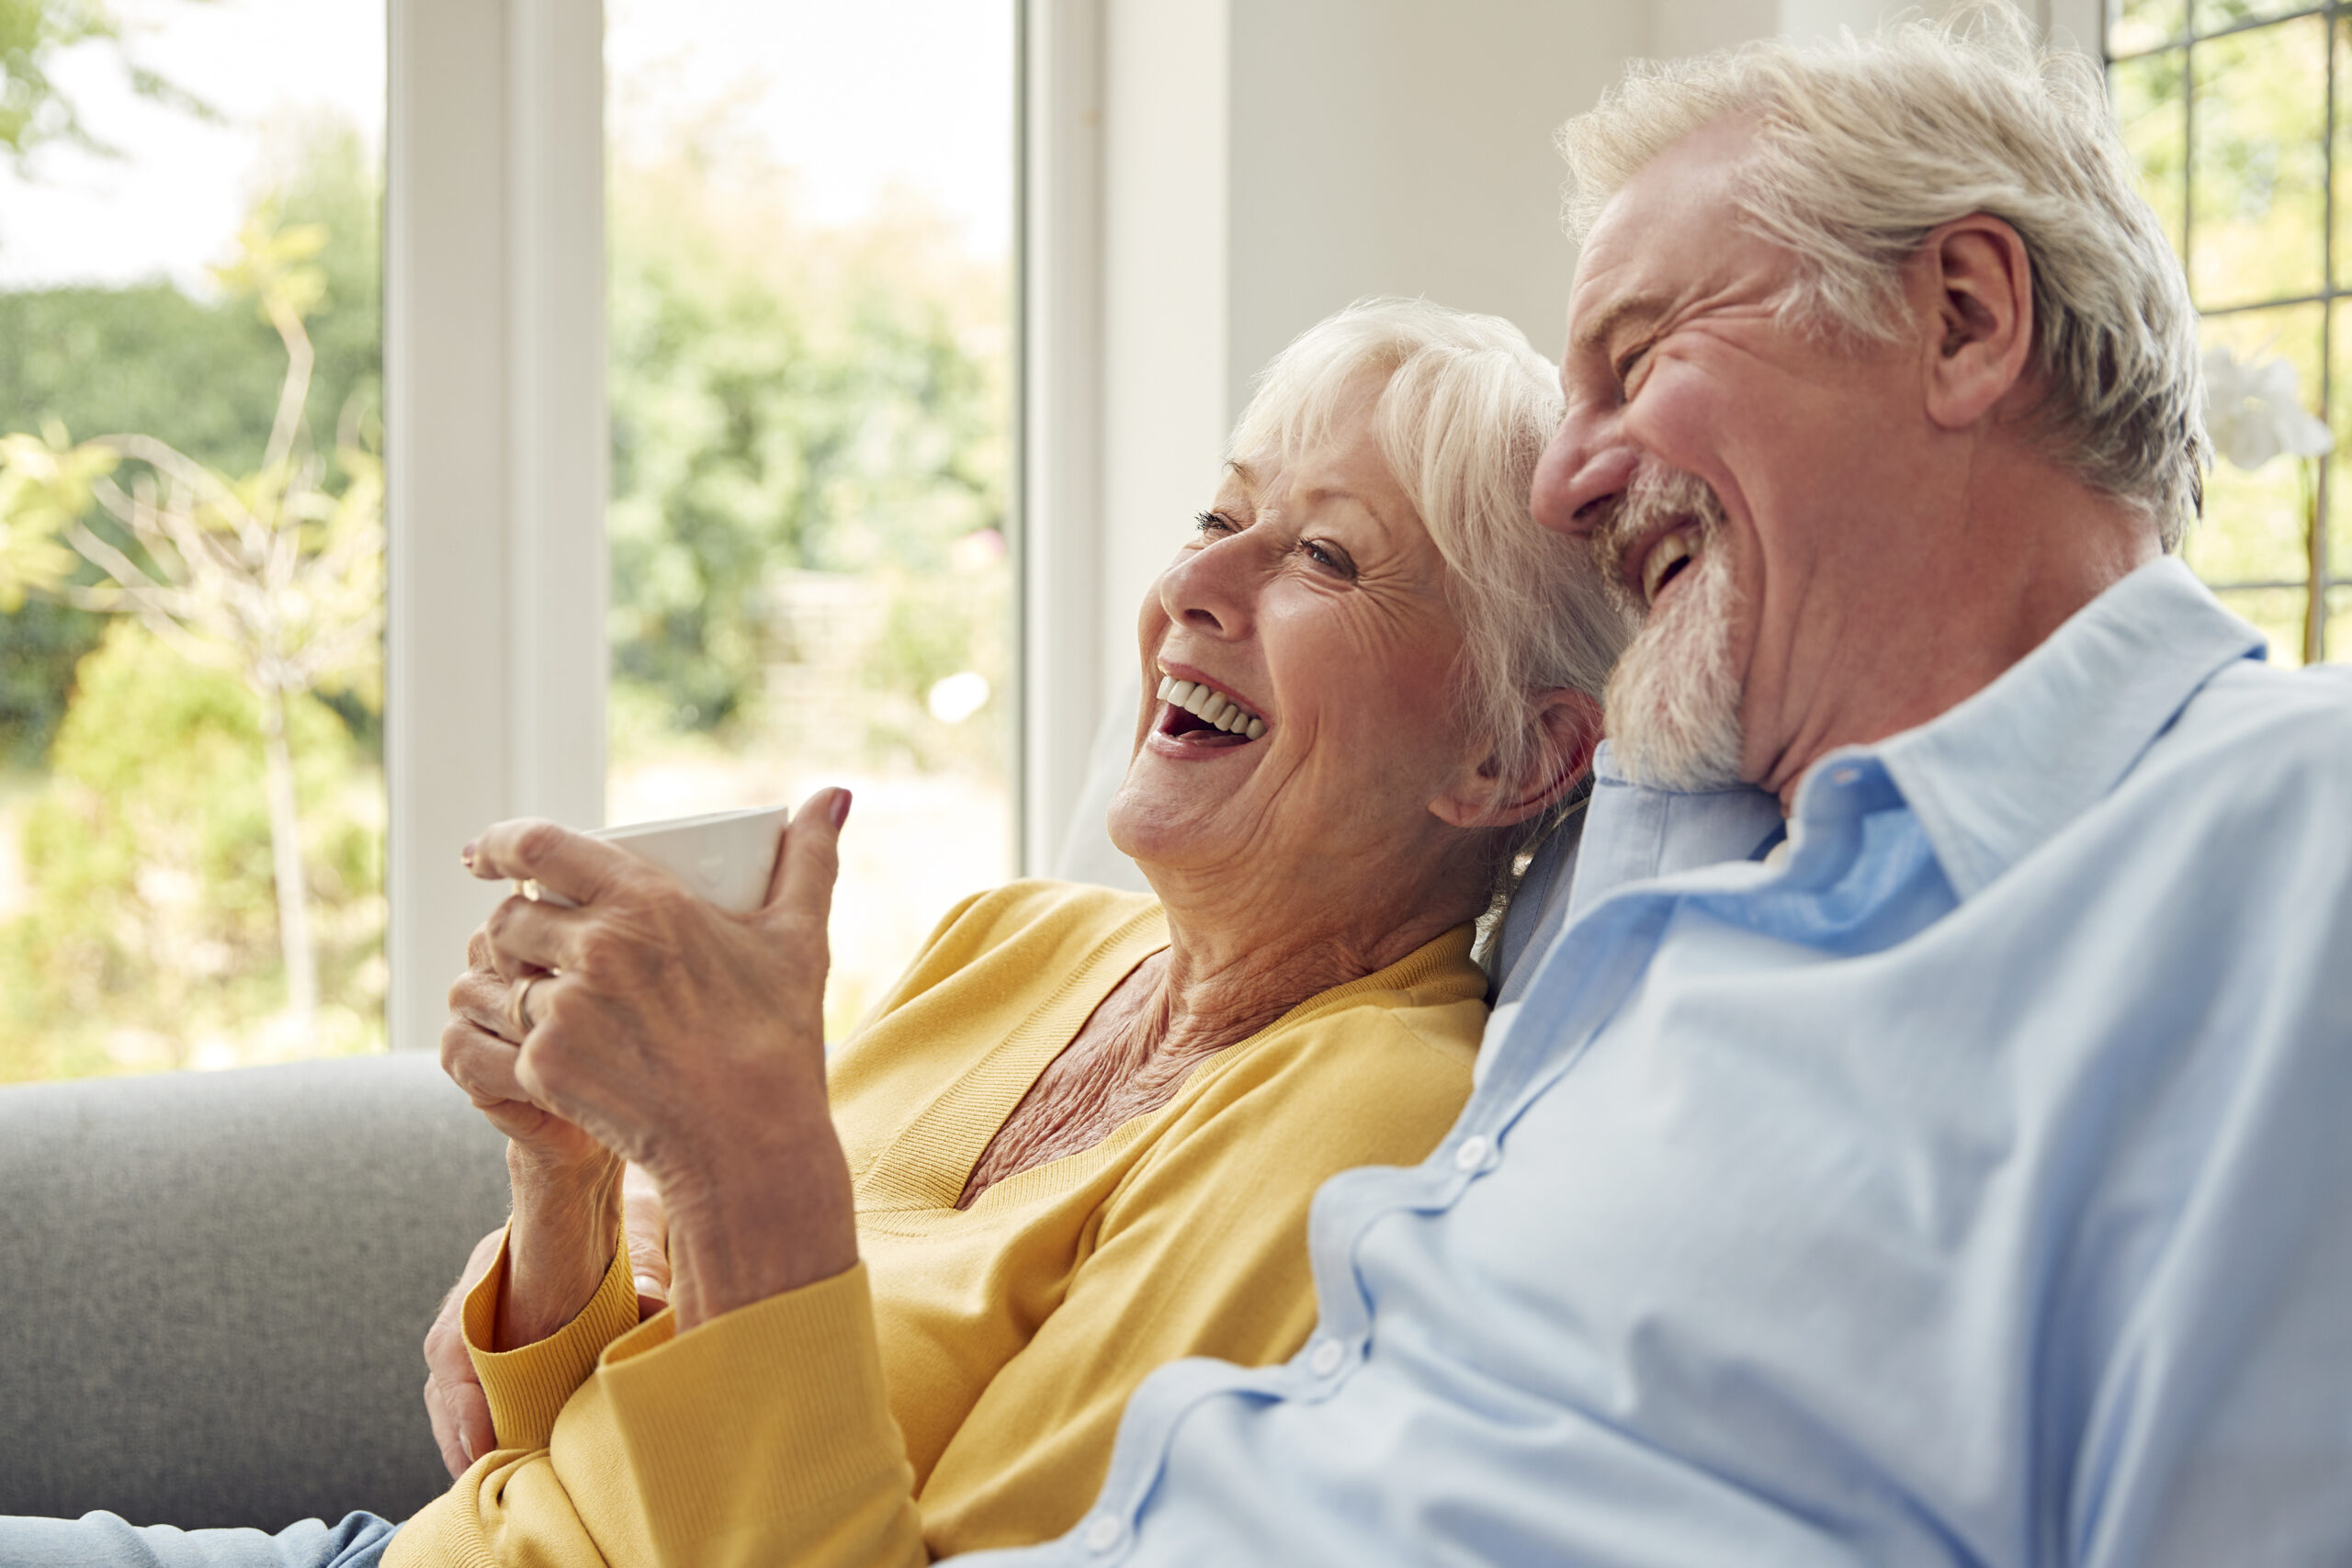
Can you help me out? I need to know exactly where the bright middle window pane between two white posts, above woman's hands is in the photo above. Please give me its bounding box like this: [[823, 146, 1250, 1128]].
[[606, 0, 1016, 1039]]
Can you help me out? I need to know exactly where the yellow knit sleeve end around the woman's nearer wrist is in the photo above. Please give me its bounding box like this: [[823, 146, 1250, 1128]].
[[597, 1265, 929, 1568]]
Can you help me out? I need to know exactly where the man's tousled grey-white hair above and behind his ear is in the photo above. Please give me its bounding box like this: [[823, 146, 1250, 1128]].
[[1559, 0, 2209, 550]]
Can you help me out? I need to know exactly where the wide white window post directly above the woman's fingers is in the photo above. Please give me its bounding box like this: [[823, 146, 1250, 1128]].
[[383, 0, 609, 1048]]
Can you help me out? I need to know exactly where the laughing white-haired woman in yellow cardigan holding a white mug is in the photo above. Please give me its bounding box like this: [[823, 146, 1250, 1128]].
[[0, 303, 1623, 1565]]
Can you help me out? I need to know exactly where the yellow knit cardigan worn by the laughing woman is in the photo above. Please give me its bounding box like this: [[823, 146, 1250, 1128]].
[[386, 882, 1487, 1568]]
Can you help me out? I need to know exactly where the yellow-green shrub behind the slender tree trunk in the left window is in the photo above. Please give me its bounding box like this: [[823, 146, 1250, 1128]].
[[0, 618, 383, 1081]]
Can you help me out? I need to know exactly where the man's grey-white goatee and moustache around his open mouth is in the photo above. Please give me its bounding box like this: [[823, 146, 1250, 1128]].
[[1597, 472, 1740, 792]]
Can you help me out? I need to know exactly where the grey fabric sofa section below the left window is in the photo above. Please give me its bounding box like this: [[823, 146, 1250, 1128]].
[[0, 1054, 505, 1528]]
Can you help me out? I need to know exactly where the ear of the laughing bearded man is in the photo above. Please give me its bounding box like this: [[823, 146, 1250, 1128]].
[[1905, 211, 2034, 430]]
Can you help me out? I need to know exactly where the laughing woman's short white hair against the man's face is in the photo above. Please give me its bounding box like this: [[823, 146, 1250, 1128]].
[[1227, 299, 1633, 822]]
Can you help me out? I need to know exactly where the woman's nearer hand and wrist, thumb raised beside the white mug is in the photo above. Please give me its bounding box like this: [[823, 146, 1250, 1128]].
[[468, 790, 856, 1328]]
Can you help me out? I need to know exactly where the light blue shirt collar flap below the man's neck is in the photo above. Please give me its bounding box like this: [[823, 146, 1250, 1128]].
[[1844, 558, 2265, 898]]
